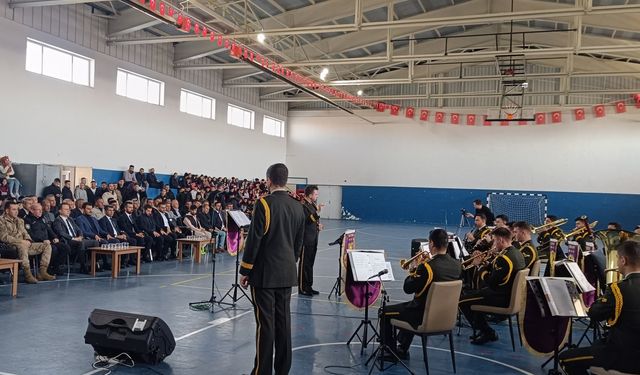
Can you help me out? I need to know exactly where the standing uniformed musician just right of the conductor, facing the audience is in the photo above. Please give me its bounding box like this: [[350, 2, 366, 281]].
[[298, 185, 322, 296]]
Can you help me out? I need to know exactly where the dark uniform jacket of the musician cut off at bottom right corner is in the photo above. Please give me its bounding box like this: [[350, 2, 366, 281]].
[[589, 273, 640, 374]]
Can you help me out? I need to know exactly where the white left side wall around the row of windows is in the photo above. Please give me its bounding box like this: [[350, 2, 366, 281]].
[[0, 17, 286, 177]]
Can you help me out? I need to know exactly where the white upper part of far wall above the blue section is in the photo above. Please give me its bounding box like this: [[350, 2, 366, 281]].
[[287, 106, 640, 194]]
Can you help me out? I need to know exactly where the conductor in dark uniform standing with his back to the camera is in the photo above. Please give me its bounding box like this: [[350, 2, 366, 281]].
[[240, 163, 305, 375]]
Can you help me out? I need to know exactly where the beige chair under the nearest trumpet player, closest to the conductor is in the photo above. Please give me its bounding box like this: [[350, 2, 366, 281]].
[[391, 280, 462, 375]]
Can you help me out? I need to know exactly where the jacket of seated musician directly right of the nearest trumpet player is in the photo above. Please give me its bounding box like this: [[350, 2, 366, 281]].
[[480, 246, 525, 294]]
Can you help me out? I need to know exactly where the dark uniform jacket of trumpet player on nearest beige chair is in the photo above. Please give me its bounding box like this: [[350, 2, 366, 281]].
[[403, 254, 462, 312]]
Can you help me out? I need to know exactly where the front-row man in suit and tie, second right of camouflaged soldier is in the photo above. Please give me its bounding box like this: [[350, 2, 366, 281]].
[[52, 203, 100, 273]]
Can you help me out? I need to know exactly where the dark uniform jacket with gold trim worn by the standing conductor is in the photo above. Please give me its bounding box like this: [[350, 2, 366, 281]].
[[240, 190, 305, 288]]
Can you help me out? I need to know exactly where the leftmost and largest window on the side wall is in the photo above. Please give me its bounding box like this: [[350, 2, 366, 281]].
[[25, 38, 95, 87]]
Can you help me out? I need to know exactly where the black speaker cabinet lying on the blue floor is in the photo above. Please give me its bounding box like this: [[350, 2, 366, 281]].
[[84, 309, 176, 364]]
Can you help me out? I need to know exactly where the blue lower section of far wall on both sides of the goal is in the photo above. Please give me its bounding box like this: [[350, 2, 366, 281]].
[[342, 186, 640, 229]]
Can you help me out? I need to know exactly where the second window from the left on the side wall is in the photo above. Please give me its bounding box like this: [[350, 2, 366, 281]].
[[116, 68, 164, 105]]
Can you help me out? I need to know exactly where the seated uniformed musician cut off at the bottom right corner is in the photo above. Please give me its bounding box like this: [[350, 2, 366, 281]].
[[560, 241, 640, 375]]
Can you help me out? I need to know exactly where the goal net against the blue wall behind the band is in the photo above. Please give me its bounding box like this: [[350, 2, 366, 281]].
[[487, 193, 547, 226]]
